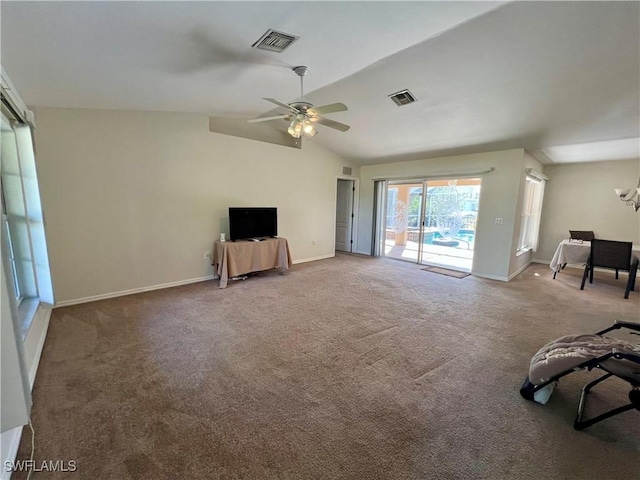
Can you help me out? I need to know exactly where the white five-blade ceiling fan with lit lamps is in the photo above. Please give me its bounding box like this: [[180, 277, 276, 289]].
[[249, 66, 351, 138]]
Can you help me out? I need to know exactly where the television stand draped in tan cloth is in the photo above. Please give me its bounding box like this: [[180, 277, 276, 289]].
[[213, 237, 291, 288]]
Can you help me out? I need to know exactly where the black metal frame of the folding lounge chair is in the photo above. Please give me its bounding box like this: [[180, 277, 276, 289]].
[[520, 321, 640, 430]]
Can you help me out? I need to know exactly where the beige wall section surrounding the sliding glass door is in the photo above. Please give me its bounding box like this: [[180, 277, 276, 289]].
[[357, 149, 525, 280]]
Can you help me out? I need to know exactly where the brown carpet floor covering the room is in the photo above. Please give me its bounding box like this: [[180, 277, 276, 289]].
[[12, 255, 640, 480]]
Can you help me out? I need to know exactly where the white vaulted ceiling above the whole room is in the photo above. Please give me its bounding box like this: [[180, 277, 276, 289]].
[[0, 0, 640, 164]]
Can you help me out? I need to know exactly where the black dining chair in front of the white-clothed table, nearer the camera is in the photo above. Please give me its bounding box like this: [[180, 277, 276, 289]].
[[580, 238, 638, 298]]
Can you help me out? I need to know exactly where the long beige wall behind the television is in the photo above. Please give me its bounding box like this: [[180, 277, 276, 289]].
[[35, 108, 359, 303]]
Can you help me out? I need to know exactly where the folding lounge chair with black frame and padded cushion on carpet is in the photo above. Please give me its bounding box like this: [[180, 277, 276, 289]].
[[520, 322, 640, 430]]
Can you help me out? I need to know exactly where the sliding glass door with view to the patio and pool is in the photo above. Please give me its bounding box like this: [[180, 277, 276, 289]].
[[384, 178, 481, 271]]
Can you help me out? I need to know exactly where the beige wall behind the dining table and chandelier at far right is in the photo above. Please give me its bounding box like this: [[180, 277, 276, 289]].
[[534, 160, 640, 262]]
